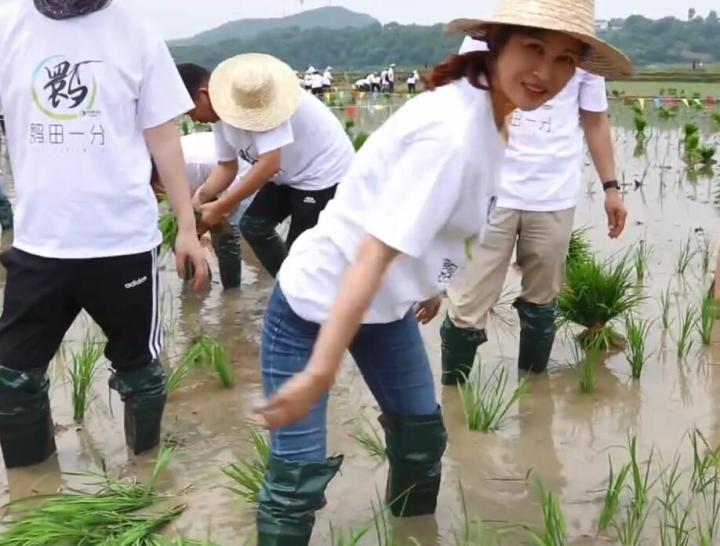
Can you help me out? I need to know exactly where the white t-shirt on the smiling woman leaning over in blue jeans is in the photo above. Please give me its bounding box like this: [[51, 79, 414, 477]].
[[279, 80, 503, 324]]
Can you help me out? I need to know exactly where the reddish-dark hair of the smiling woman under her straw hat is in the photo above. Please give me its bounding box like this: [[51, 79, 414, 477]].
[[423, 25, 584, 91]]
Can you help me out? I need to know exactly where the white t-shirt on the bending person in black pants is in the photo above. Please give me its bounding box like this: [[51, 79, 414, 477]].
[[213, 93, 355, 191]]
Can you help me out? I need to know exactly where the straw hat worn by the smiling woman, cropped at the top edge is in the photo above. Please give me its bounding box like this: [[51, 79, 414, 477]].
[[446, 0, 633, 78]]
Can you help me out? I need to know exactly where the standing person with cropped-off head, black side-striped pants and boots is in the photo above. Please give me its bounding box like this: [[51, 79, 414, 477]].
[[0, 0, 207, 469]]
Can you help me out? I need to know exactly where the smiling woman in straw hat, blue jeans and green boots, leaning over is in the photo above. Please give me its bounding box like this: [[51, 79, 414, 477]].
[[252, 0, 631, 546]]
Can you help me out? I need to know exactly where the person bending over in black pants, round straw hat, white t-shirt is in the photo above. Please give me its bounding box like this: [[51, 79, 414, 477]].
[[179, 53, 355, 277]]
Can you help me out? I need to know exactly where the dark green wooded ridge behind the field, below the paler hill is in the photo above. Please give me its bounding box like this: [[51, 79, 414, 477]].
[[171, 10, 720, 73]]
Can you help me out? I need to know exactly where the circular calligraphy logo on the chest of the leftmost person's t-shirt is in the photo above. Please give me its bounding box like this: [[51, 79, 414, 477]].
[[32, 55, 102, 121]]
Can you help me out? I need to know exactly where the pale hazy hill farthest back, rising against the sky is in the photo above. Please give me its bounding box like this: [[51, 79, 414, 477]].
[[171, 7, 378, 46]]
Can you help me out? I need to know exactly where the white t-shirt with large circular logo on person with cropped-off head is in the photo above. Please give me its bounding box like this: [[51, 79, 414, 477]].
[[0, 0, 193, 258]]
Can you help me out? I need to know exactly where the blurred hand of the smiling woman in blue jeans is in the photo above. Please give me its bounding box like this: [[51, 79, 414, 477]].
[[256, 364, 334, 429]]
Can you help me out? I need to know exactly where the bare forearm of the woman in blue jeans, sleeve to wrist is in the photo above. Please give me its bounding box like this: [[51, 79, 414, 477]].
[[308, 236, 398, 378]]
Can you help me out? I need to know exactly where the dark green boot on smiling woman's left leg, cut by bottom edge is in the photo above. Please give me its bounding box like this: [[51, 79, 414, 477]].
[[256, 450, 343, 546]]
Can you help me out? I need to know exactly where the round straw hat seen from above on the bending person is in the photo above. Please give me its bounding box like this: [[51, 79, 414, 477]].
[[209, 53, 302, 132]]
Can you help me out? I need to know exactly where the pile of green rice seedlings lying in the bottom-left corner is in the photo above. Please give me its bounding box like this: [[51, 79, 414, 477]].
[[0, 449, 180, 546]]
